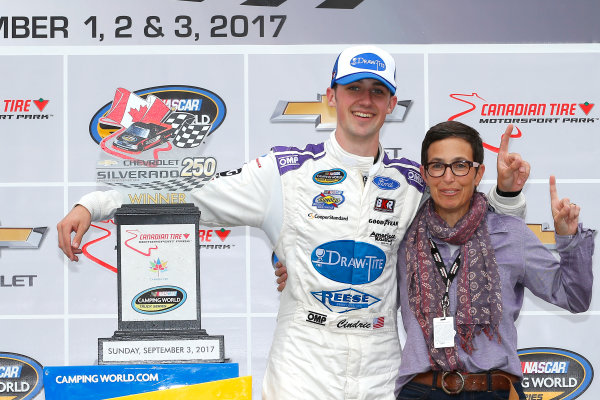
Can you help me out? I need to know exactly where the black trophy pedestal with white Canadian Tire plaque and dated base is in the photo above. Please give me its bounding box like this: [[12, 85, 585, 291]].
[[98, 203, 227, 365]]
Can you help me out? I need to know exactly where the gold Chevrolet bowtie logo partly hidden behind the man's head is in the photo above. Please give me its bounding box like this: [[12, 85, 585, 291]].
[[271, 94, 412, 131]]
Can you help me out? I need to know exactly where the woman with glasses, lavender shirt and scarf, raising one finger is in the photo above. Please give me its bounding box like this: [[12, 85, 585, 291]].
[[396, 121, 595, 400]]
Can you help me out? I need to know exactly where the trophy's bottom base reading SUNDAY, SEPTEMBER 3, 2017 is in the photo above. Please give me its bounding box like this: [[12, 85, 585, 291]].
[[98, 330, 229, 365]]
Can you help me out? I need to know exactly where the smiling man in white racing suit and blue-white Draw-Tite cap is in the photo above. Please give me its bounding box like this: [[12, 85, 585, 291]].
[[58, 46, 529, 400]]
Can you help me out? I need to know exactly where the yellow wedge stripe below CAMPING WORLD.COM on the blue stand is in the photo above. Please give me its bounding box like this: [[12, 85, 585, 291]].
[[106, 376, 252, 400]]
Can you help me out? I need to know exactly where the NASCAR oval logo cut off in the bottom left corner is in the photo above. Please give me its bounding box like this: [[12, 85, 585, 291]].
[[0, 353, 43, 400]]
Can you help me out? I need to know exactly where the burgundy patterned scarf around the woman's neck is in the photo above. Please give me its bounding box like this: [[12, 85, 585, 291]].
[[406, 192, 502, 371]]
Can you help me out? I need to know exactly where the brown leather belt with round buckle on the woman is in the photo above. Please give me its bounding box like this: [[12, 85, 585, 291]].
[[411, 371, 521, 394]]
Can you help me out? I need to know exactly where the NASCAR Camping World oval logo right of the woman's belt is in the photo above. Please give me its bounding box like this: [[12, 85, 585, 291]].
[[518, 347, 594, 400]]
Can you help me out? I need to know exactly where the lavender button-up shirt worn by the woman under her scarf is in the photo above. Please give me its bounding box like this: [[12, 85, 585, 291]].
[[396, 212, 595, 392]]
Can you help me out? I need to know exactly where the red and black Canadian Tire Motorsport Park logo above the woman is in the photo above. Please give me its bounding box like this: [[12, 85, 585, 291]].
[[448, 92, 600, 153]]
